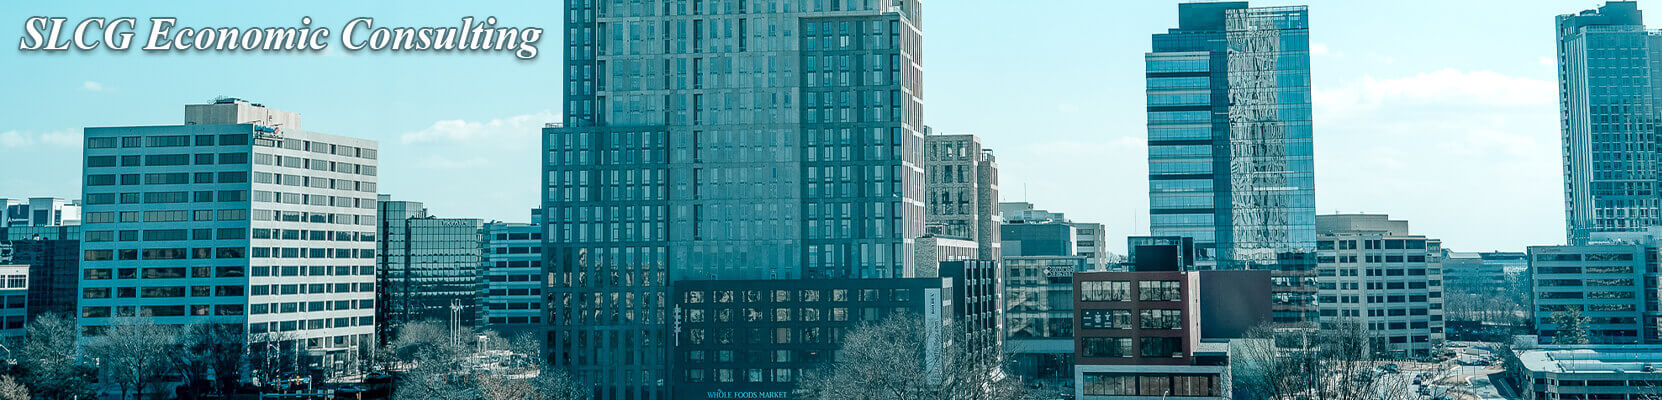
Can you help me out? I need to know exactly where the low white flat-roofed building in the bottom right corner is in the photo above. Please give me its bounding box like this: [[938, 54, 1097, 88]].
[[1516, 345, 1662, 400]]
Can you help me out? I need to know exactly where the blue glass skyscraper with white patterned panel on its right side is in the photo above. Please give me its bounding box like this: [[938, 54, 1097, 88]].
[[1145, 2, 1316, 322]]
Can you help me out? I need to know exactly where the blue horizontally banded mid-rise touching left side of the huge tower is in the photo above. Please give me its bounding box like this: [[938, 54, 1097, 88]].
[[479, 209, 543, 337]]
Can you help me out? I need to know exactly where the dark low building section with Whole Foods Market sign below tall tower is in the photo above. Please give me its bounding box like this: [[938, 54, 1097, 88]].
[[670, 277, 957, 398]]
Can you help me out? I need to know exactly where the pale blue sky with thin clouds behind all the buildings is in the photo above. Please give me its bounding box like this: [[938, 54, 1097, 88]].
[[0, 0, 1602, 251]]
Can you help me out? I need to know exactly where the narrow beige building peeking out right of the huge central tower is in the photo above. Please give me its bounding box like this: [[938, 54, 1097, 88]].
[[924, 131, 1002, 261]]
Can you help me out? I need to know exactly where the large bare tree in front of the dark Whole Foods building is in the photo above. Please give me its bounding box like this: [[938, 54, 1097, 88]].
[[798, 314, 1022, 400]]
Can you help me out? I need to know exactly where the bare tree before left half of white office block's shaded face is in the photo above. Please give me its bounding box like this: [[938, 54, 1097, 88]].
[[86, 317, 176, 398]]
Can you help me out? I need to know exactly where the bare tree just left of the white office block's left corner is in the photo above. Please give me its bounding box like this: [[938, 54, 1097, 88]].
[[17, 314, 93, 400]]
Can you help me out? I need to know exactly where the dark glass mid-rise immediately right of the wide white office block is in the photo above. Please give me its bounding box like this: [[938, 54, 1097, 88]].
[[376, 194, 485, 340]]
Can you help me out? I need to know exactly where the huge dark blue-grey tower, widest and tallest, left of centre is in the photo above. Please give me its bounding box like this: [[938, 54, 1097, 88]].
[[543, 0, 924, 398]]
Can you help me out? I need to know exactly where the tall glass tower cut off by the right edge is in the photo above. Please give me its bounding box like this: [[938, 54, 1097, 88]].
[[1556, 2, 1662, 244]]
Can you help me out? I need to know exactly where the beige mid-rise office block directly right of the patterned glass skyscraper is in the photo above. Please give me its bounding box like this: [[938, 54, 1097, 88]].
[[1316, 214, 1444, 357]]
